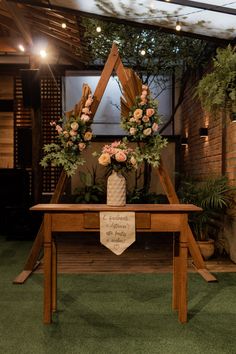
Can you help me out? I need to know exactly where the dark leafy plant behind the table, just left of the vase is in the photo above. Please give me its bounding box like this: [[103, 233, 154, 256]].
[[74, 171, 105, 204]]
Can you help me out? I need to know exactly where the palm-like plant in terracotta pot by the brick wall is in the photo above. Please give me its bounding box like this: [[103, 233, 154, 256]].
[[178, 176, 236, 259]]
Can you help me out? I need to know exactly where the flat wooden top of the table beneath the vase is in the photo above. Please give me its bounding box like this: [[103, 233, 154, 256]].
[[30, 204, 202, 213]]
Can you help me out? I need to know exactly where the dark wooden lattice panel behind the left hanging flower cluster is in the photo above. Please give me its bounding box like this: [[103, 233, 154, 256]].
[[41, 77, 62, 193]]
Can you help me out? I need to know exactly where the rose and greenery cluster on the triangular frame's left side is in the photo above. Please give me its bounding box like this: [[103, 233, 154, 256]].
[[40, 94, 93, 176]]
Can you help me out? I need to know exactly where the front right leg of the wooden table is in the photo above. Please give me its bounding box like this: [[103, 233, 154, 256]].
[[178, 215, 188, 323]]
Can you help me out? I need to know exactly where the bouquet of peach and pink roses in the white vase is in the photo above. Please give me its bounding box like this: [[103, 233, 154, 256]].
[[94, 138, 138, 172]]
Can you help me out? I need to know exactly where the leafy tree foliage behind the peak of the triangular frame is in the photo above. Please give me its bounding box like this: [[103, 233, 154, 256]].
[[82, 17, 213, 90]]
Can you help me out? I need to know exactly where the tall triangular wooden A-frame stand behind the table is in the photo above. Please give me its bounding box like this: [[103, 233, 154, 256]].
[[13, 44, 216, 284]]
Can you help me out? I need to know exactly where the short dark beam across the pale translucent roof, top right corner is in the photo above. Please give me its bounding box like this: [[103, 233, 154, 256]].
[[156, 0, 236, 16]]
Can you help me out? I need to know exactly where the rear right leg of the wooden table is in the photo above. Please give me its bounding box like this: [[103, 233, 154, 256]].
[[172, 233, 180, 310]]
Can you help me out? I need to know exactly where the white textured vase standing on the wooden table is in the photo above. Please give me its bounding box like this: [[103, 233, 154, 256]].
[[107, 171, 126, 206]]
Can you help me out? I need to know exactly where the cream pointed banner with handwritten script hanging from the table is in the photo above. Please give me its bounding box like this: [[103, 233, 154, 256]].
[[100, 211, 135, 256]]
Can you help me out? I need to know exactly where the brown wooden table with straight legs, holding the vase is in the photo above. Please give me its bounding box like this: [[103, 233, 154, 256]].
[[31, 204, 201, 324]]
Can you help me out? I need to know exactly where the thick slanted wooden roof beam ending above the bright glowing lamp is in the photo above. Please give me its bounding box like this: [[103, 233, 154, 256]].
[[2, 0, 33, 46]]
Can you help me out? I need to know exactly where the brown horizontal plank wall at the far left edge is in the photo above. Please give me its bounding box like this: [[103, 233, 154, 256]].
[[0, 76, 14, 168]]
